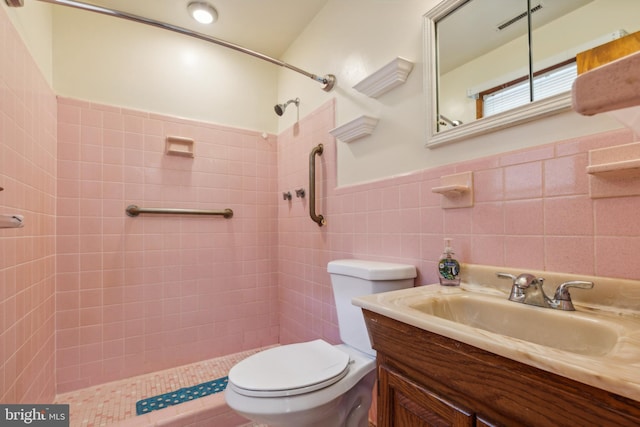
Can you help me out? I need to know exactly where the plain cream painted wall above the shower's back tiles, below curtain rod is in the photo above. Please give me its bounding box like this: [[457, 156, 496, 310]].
[[53, 7, 278, 132]]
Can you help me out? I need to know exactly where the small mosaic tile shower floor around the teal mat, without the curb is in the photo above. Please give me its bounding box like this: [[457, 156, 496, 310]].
[[55, 349, 262, 427]]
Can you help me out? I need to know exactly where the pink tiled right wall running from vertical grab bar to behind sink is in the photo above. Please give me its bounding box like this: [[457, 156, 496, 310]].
[[278, 102, 640, 343]]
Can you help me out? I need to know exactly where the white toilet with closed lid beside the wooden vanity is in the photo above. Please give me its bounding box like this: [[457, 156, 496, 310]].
[[225, 259, 416, 427]]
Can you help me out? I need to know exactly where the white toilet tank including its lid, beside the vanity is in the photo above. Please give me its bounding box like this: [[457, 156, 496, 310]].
[[327, 259, 416, 356]]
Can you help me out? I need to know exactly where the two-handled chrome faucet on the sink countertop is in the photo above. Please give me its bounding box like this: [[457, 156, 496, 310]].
[[496, 273, 593, 311]]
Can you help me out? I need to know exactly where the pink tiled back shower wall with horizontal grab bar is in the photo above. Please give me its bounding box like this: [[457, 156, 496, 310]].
[[56, 99, 278, 392]]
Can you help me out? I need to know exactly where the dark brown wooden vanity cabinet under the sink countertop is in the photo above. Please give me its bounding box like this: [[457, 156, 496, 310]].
[[363, 310, 640, 427]]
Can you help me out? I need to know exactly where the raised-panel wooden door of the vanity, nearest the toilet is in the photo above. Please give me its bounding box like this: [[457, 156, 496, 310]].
[[378, 366, 475, 427]]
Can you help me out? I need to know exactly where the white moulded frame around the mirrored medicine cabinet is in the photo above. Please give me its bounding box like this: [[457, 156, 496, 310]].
[[422, 0, 571, 148]]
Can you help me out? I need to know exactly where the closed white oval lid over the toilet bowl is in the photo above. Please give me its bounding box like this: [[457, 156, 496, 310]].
[[229, 340, 349, 397]]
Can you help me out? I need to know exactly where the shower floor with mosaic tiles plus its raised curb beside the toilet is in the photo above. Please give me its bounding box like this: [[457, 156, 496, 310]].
[[55, 348, 272, 427]]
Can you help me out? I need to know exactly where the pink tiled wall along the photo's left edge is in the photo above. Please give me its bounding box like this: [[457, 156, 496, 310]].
[[0, 7, 56, 403]]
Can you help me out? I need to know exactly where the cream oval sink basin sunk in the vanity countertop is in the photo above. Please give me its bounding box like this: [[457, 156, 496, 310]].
[[409, 293, 619, 356]]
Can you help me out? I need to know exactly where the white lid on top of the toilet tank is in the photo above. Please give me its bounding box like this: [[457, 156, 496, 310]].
[[327, 259, 417, 280]]
